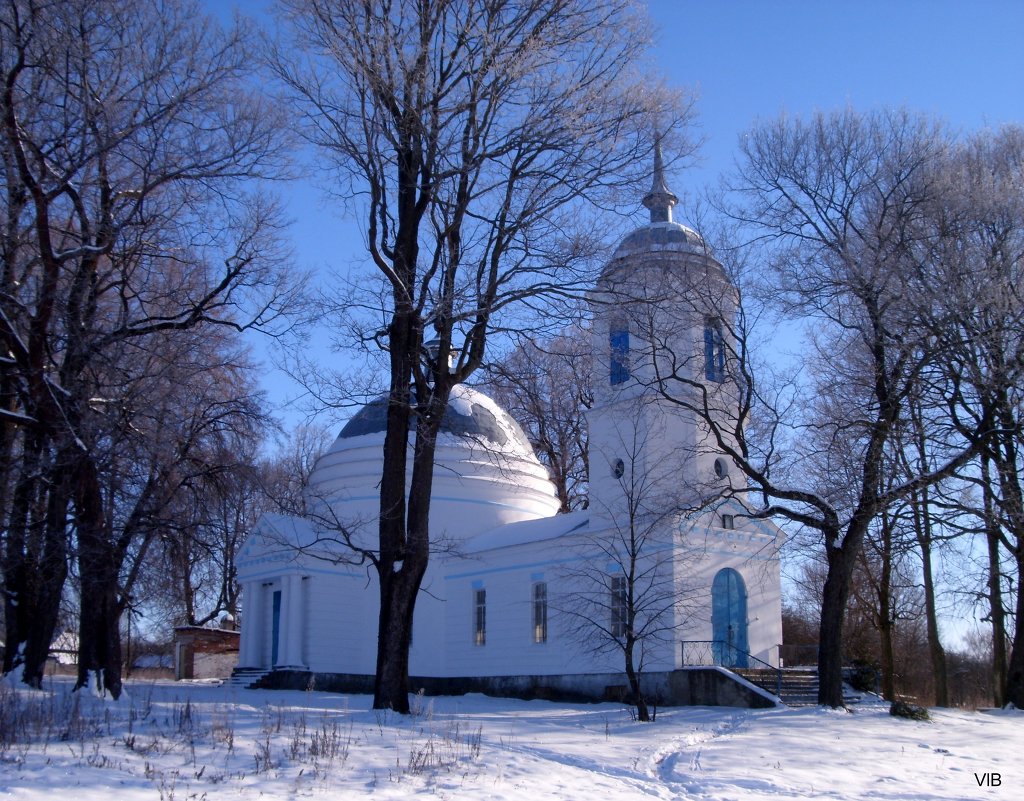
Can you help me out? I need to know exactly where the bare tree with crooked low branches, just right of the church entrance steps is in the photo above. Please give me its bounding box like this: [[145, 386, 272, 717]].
[[634, 111, 972, 707]]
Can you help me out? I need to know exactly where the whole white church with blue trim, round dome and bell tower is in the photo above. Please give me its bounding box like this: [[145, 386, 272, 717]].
[[236, 158, 782, 704]]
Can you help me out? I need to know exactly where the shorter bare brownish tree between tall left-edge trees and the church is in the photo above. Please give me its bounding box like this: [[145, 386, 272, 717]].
[[74, 330, 268, 695]]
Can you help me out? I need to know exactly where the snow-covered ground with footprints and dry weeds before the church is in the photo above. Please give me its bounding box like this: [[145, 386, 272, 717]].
[[0, 678, 1024, 801]]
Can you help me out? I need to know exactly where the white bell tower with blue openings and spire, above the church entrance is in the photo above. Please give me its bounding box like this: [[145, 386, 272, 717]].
[[588, 143, 740, 526]]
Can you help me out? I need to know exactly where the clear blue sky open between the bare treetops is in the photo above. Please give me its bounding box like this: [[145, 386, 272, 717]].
[[203, 0, 1024, 419]]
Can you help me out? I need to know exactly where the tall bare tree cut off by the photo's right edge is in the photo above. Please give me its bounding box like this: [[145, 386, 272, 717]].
[[925, 126, 1024, 707]]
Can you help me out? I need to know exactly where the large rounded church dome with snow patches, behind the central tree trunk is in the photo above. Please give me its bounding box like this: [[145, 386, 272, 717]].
[[308, 384, 559, 539]]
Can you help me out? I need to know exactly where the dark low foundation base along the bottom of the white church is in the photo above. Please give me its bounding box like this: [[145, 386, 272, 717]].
[[247, 668, 775, 709]]
